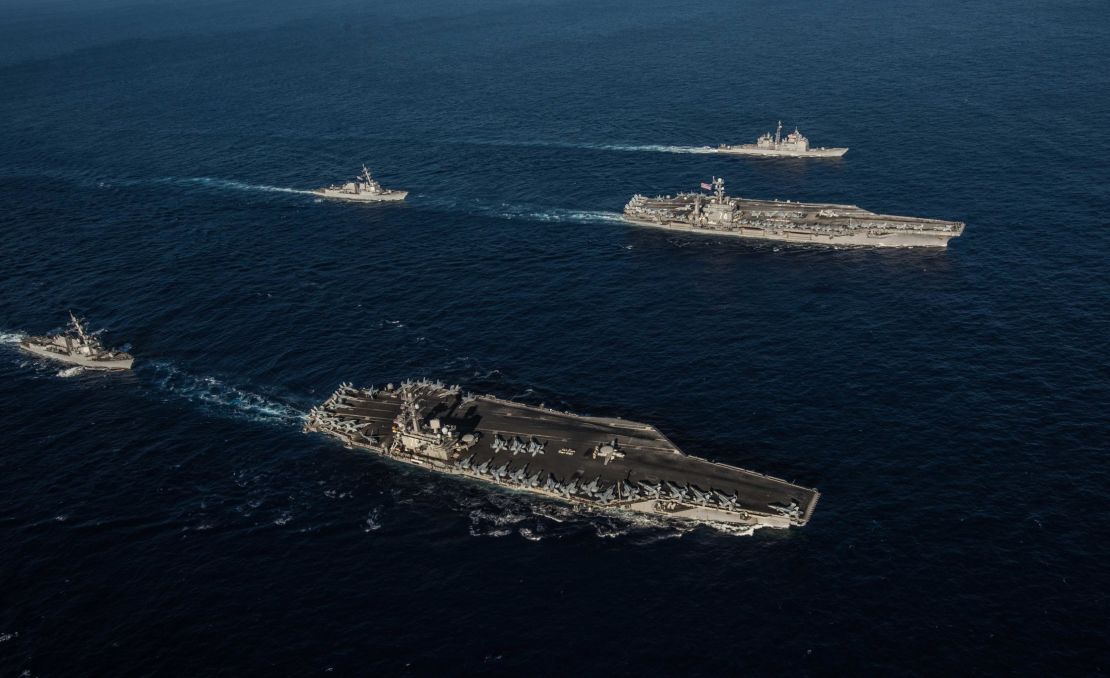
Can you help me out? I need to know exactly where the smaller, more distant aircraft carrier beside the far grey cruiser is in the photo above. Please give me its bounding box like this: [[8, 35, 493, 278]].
[[624, 178, 963, 247]]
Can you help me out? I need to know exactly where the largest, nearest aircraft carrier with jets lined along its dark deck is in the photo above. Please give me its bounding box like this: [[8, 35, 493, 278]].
[[304, 381, 819, 528]]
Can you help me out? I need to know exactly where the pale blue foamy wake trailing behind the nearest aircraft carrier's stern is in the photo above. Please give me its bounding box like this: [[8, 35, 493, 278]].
[[134, 361, 304, 425]]
